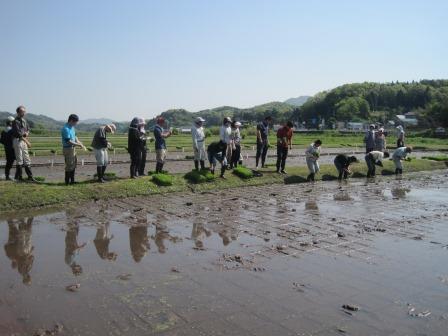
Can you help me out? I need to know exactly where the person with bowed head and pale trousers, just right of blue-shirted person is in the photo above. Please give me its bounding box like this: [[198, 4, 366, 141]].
[[92, 124, 117, 183]]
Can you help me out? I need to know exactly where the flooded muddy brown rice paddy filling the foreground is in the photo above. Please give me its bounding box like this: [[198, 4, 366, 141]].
[[0, 172, 448, 335]]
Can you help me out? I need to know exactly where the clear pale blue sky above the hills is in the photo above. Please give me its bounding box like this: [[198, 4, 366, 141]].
[[0, 0, 448, 121]]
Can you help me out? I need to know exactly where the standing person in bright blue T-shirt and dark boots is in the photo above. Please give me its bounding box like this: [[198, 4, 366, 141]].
[[61, 114, 86, 185]]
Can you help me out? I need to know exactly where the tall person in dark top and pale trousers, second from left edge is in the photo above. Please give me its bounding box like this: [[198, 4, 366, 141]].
[[12, 106, 36, 182]]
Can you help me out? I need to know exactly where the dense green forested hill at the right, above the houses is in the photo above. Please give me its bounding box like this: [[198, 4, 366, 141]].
[[299, 80, 448, 127]]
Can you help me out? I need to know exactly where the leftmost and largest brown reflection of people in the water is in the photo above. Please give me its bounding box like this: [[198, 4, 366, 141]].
[[5, 217, 34, 285]]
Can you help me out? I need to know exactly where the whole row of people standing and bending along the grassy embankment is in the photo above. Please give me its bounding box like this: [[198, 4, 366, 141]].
[[0, 106, 412, 185]]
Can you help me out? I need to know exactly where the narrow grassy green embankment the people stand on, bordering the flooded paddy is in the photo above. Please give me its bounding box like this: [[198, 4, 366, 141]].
[[0, 159, 447, 212]]
